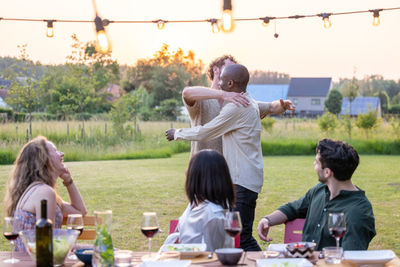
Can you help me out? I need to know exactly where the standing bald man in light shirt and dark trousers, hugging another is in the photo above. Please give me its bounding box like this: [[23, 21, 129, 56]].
[[166, 64, 264, 251]]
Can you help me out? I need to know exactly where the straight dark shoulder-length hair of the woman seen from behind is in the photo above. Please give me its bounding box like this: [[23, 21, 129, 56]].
[[185, 149, 235, 209]]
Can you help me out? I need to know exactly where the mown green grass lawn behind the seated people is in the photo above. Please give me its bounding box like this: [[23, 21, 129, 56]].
[[0, 153, 400, 255]]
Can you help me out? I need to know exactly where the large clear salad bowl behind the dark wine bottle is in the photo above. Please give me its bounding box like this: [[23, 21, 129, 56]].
[[19, 229, 79, 266]]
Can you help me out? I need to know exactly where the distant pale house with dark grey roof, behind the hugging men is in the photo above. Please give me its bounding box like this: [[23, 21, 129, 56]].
[[287, 78, 332, 117]]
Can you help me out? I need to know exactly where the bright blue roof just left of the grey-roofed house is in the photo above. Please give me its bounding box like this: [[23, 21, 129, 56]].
[[247, 84, 289, 102]]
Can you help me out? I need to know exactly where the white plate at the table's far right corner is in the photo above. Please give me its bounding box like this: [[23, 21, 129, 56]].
[[343, 250, 396, 264]]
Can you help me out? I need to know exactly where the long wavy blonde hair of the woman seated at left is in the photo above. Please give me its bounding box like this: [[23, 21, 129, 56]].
[[3, 136, 59, 216]]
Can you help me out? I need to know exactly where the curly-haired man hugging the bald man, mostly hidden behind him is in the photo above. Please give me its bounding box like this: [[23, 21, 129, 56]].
[[182, 55, 295, 156]]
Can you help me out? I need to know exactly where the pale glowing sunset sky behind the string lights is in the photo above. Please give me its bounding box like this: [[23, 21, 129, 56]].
[[0, 0, 400, 80]]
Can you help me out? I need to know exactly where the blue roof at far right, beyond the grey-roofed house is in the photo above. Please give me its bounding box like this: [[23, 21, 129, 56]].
[[340, 96, 381, 115]]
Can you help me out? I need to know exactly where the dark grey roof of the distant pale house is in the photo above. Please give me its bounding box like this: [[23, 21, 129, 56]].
[[288, 78, 332, 97]]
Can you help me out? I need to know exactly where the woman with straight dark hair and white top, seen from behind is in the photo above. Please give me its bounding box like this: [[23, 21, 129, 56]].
[[165, 150, 235, 251]]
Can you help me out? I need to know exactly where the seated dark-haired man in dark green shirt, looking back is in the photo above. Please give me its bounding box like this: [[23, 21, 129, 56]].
[[257, 139, 376, 250]]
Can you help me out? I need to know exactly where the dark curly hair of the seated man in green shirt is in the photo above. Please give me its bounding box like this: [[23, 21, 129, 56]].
[[316, 139, 360, 181]]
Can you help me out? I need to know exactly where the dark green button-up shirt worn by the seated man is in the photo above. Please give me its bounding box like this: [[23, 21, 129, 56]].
[[278, 183, 376, 250]]
